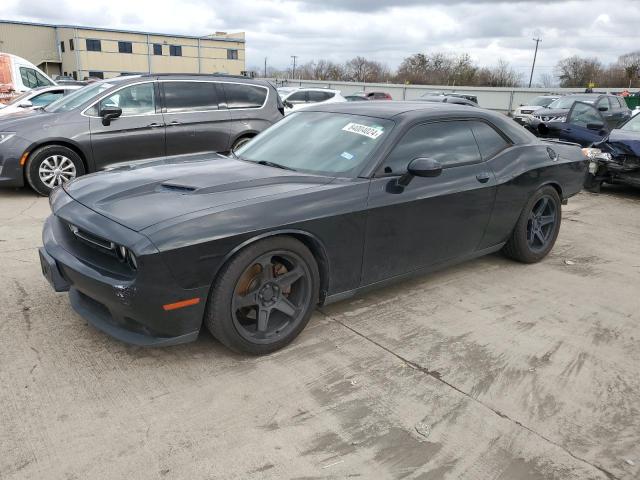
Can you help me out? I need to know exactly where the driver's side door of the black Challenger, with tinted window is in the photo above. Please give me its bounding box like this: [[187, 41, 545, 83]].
[[362, 120, 496, 285]]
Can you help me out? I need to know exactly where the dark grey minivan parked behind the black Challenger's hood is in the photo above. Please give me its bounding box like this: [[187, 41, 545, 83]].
[[0, 75, 284, 195]]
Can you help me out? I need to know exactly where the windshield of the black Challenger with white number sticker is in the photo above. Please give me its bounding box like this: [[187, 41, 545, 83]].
[[236, 112, 394, 177]]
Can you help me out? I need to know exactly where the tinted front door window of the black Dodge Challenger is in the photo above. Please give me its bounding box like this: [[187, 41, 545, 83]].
[[383, 121, 481, 174]]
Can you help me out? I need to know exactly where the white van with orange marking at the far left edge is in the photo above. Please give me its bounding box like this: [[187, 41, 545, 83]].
[[0, 52, 56, 103]]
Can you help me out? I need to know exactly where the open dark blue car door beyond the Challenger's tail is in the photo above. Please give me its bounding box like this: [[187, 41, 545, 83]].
[[550, 102, 609, 147]]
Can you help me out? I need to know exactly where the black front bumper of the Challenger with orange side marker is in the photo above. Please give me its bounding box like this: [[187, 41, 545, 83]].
[[40, 206, 208, 346]]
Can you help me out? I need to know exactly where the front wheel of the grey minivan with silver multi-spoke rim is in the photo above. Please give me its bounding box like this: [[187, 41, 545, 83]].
[[25, 145, 85, 197]]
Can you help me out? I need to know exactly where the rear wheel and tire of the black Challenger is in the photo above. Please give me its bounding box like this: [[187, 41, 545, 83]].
[[502, 186, 562, 263]]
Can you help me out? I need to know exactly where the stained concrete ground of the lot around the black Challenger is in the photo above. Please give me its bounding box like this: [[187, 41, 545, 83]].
[[0, 188, 640, 480]]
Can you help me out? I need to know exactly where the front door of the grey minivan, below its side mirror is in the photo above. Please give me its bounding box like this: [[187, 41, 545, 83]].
[[85, 82, 165, 170]]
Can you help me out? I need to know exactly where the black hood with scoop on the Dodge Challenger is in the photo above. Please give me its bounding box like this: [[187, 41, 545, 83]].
[[64, 155, 333, 231]]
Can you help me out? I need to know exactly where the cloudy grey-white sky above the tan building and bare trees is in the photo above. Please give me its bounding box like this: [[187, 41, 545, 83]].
[[0, 0, 640, 80]]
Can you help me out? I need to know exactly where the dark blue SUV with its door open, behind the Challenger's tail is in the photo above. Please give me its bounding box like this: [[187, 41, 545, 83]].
[[529, 93, 631, 132]]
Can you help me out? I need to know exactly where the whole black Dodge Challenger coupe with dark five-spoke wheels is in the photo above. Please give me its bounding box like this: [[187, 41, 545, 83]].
[[40, 102, 586, 354]]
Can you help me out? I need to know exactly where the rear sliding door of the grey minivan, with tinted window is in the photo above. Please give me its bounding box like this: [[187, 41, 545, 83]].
[[160, 80, 231, 155]]
